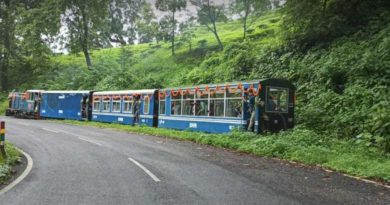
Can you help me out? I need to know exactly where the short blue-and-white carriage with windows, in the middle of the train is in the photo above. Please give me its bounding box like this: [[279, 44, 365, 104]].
[[92, 90, 158, 127]]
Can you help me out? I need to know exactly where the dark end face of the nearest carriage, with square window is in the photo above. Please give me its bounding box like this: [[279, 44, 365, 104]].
[[261, 86, 293, 132]]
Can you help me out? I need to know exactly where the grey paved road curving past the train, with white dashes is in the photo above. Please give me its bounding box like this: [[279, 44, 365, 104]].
[[0, 118, 390, 205]]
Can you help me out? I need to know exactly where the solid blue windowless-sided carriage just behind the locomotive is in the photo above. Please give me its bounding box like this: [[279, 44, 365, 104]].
[[40, 91, 93, 120]]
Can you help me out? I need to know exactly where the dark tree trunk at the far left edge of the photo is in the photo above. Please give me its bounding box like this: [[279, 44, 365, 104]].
[[0, 0, 12, 91]]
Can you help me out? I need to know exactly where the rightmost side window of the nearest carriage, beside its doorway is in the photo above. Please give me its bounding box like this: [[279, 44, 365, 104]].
[[226, 89, 243, 117]]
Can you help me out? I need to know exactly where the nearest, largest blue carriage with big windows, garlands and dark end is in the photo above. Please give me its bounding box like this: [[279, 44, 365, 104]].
[[158, 79, 295, 133]]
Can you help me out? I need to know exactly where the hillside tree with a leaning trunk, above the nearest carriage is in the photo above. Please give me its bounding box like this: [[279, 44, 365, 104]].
[[191, 0, 227, 50]]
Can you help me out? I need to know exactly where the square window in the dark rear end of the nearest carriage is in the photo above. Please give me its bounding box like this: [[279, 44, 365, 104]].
[[266, 87, 288, 112]]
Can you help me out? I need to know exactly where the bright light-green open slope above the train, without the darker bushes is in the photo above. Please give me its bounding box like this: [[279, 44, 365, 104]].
[[44, 13, 281, 90]]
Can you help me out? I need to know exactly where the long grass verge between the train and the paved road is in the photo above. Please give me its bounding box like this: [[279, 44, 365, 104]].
[[61, 121, 390, 183]]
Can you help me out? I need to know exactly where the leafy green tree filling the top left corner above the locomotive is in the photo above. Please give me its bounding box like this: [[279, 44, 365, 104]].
[[0, 0, 61, 91]]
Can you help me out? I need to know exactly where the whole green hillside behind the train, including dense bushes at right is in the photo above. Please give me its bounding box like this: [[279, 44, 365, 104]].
[[36, 11, 390, 152]]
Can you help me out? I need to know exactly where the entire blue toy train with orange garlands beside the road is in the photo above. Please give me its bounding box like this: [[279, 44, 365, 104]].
[[6, 79, 295, 133]]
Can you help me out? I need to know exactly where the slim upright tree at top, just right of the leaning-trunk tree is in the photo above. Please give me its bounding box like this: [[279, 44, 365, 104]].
[[230, 0, 271, 39]]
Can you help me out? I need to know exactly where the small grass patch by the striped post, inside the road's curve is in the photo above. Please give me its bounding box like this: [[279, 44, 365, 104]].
[[0, 142, 21, 184]]
